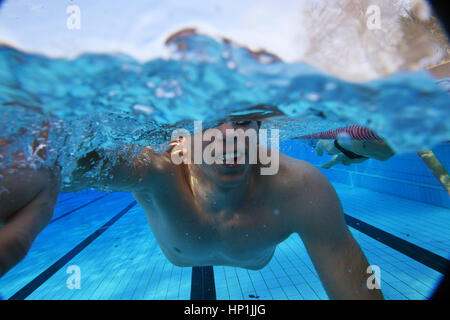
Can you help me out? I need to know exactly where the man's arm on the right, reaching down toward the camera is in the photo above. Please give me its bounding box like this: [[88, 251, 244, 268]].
[[294, 166, 383, 299]]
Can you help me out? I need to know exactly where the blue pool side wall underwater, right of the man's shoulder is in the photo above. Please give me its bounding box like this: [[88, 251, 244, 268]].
[[280, 140, 450, 208]]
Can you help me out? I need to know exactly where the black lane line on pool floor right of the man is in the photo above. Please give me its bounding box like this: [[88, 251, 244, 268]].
[[344, 214, 449, 274]]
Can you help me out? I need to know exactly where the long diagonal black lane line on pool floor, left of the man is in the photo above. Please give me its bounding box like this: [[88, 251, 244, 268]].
[[8, 201, 136, 300]]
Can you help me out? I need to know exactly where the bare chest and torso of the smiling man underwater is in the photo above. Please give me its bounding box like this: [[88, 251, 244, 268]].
[[133, 154, 298, 269]]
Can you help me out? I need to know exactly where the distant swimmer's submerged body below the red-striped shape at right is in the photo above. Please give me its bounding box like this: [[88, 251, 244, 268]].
[[316, 139, 394, 169]]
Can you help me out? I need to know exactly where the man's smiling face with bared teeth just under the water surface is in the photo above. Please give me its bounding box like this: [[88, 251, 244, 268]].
[[198, 120, 258, 187]]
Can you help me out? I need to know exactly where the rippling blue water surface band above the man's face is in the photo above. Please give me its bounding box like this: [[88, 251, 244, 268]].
[[0, 34, 450, 184]]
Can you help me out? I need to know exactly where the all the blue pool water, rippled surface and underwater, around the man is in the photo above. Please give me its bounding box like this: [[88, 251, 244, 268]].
[[0, 7, 450, 300]]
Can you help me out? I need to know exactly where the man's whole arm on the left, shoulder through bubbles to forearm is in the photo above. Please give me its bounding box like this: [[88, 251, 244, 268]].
[[0, 122, 162, 277]]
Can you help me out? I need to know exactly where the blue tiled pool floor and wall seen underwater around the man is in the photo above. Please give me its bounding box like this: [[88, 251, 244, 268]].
[[0, 141, 450, 300]]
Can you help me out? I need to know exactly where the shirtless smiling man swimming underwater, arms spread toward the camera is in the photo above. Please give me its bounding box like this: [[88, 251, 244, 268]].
[[0, 120, 383, 299]]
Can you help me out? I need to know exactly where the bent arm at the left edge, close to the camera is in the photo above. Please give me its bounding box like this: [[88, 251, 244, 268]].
[[0, 122, 60, 277]]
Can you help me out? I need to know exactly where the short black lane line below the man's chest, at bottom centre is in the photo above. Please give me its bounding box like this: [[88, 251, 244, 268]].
[[191, 266, 216, 300]]
